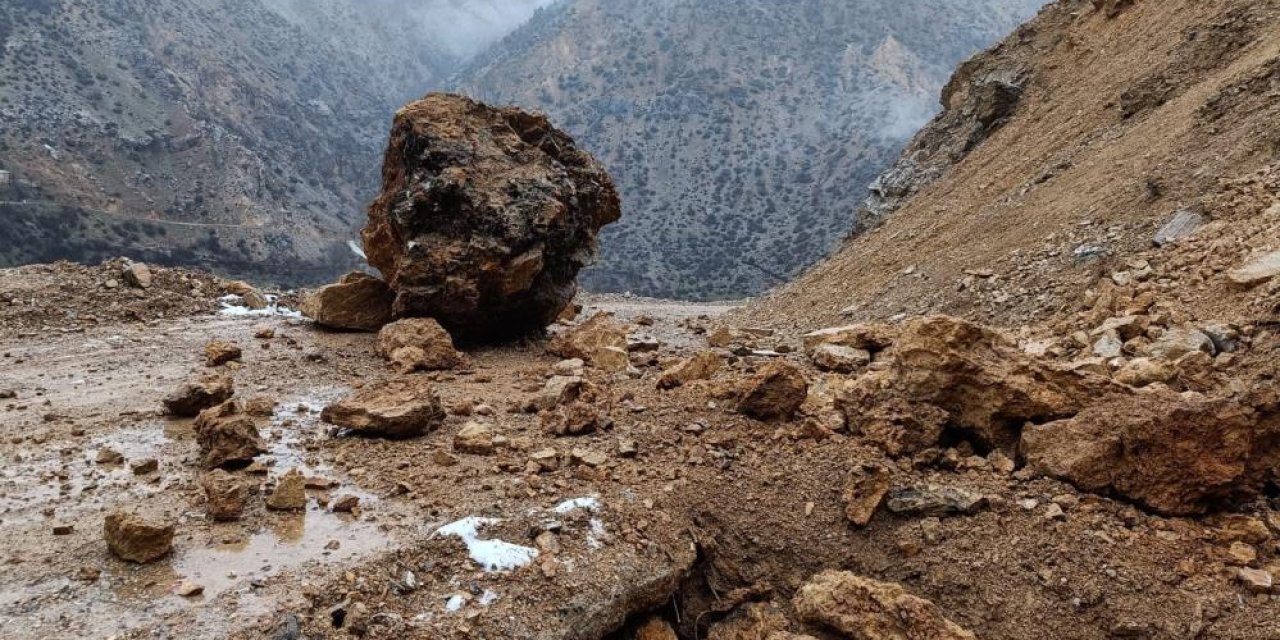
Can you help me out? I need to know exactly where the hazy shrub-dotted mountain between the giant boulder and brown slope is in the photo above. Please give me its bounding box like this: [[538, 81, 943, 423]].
[[454, 0, 1043, 298]]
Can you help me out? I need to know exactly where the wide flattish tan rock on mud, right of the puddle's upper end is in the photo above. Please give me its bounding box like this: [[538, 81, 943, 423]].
[[320, 376, 444, 438]]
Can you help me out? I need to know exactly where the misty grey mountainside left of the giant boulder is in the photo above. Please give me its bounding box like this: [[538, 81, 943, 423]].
[[0, 0, 541, 284]]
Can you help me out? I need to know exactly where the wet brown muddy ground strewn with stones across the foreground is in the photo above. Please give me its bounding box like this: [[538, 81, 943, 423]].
[[0, 264, 1280, 640]]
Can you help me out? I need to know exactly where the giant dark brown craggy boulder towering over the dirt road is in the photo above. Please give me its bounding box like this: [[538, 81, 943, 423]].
[[364, 93, 622, 340]]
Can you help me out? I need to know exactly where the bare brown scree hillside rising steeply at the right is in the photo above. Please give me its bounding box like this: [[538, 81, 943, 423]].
[[742, 0, 1280, 330]]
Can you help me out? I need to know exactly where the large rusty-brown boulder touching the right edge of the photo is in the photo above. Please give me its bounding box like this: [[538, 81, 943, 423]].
[[1021, 393, 1280, 516]]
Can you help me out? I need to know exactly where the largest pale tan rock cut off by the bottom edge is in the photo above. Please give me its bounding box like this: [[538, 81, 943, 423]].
[[791, 571, 975, 640]]
